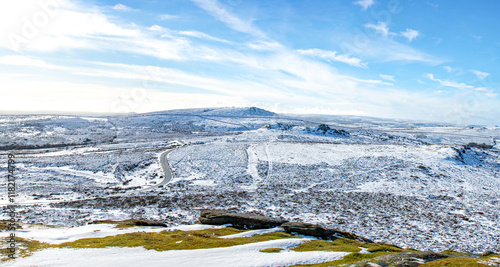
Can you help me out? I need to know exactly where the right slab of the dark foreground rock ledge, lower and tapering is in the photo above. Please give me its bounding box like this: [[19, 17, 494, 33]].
[[281, 222, 373, 243]]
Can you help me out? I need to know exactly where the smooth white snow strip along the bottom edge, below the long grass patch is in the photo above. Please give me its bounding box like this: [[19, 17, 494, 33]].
[[2, 241, 349, 267]]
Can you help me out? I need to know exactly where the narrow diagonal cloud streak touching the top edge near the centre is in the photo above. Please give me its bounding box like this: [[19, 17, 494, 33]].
[[192, 0, 266, 38]]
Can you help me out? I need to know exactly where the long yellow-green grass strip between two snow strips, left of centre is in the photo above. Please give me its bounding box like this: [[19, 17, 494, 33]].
[[57, 228, 298, 251]]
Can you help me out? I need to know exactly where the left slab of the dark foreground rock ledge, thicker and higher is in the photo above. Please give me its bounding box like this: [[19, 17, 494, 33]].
[[199, 210, 287, 229]]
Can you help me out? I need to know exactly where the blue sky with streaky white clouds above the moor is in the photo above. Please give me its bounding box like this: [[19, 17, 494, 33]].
[[0, 0, 500, 125]]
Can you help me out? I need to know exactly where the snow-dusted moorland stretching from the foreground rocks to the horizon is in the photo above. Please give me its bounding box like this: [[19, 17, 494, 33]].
[[0, 108, 500, 255]]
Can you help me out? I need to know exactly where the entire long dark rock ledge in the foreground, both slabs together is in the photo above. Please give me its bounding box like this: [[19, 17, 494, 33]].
[[199, 210, 373, 243]]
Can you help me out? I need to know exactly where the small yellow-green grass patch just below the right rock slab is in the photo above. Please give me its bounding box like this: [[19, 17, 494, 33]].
[[293, 238, 362, 252]]
